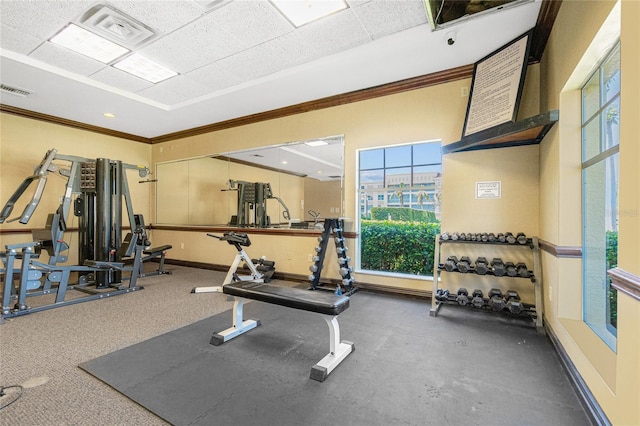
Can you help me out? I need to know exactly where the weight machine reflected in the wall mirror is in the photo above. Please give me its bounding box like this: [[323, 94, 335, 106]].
[[228, 180, 291, 228]]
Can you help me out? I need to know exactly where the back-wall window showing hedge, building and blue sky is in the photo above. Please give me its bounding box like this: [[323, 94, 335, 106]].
[[356, 142, 442, 276]]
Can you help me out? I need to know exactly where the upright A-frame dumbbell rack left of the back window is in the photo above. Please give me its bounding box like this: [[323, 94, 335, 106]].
[[309, 218, 358, 295]]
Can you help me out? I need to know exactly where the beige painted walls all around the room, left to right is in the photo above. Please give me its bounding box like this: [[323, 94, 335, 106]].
[[0, 0, 640, 425]]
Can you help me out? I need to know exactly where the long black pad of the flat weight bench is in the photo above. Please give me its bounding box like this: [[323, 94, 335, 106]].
[[222, 281, 349, 315]]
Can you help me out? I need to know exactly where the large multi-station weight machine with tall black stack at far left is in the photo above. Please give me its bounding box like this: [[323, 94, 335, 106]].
[[0, 149, 169, 318]]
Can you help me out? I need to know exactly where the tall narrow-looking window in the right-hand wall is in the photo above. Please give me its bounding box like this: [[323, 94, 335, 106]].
[[582, 44, 620, 351]]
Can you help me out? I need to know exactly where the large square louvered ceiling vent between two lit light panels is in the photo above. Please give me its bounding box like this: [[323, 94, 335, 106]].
[[76, 4, 156, 49]]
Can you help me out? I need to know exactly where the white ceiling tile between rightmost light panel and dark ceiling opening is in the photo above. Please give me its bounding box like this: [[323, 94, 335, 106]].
[[353, 0, 428, 39]]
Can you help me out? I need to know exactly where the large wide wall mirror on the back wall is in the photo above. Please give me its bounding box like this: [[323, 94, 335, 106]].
[[156, 135, 344, 229]]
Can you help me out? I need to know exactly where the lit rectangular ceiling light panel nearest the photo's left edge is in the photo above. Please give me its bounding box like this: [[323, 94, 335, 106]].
[[49, 24, 129, 64]]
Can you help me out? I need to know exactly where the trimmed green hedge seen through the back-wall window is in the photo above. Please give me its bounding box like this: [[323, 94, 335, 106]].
[[360, 220, 440, 276]]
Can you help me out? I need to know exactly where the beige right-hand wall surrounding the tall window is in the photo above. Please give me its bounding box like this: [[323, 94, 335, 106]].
[[540, 0, 640, 425]]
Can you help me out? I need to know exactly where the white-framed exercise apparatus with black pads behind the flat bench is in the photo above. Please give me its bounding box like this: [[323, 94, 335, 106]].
[[191, 232, 276, 293]]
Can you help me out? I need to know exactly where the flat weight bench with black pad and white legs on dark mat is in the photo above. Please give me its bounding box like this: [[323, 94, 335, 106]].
[[211, 281, 355, 382]]
